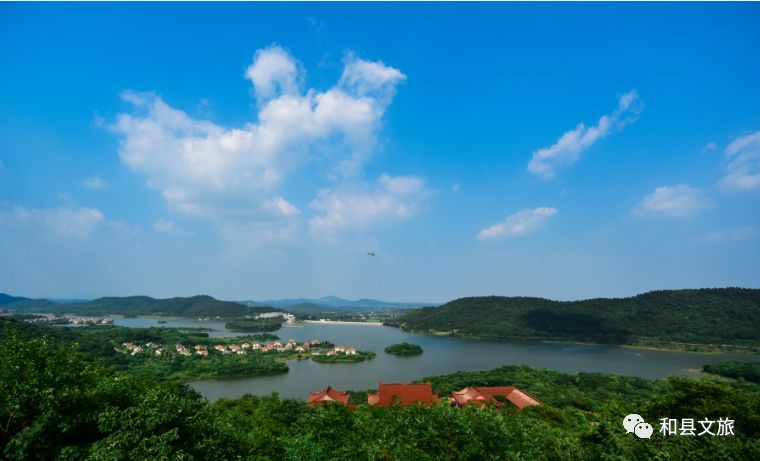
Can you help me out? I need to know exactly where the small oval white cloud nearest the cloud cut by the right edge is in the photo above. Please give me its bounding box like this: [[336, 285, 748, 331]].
[[631, 184, 713, 217]]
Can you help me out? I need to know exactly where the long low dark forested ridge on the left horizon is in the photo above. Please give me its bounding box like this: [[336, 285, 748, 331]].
[[0, 293, 285, 318]]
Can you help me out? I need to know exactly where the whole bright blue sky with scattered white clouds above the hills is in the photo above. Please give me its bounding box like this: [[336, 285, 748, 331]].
[[0, 3, 760, 302]]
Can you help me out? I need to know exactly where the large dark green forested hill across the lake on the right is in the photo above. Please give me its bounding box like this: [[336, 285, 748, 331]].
[[385, 288, 760, 345]]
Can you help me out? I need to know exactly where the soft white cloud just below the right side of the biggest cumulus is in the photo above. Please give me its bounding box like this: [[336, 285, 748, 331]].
[[309, 174, 429, 241]]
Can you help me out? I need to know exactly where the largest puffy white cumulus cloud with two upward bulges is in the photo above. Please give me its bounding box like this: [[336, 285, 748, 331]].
[[110, 45, 406, 220]]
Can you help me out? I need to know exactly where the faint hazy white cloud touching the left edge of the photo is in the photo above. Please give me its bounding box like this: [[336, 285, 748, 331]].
[[0, 207, 105, 237]]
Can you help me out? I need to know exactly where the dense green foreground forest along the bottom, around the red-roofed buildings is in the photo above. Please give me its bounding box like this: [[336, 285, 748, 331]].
[[0, 328, 760, 461]]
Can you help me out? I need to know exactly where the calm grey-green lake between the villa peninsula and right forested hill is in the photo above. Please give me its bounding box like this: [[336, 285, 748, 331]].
[[183, 319, 760, 400]]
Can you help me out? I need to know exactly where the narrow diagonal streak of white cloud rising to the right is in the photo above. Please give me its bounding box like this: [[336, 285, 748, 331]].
[[528, 90, 644, 179]]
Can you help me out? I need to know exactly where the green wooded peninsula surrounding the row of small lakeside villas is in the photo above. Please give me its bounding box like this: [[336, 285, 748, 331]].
[[0, 320, 286, 381]]
